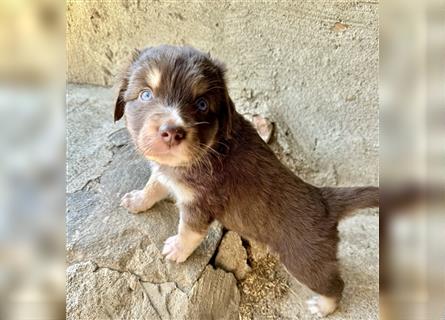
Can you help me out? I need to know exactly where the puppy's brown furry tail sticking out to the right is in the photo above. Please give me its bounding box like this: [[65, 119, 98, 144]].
[[320, 187, 380, 220]]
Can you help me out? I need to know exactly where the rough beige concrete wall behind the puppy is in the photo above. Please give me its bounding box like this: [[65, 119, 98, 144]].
[[67, 0, 378, 185]]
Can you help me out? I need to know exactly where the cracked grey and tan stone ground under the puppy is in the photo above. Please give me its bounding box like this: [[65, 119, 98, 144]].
[[66, 85, 379, 320]]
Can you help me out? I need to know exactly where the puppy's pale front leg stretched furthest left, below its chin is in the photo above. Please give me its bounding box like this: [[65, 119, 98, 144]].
[[121, 172, 169, 213]]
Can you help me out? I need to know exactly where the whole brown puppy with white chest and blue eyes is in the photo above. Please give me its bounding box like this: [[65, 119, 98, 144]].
[[115, 46, 379, 316]]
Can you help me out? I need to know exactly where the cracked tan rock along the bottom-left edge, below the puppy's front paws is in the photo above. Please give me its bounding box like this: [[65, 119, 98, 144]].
[[66, 261, 240, 320]]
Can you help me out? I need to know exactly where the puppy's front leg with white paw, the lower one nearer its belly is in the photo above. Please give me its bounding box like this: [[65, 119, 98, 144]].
[[162, 209, 209, 263]]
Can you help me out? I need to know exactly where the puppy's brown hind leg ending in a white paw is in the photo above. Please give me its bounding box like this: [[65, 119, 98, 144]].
[[281, 246, 344, 317]]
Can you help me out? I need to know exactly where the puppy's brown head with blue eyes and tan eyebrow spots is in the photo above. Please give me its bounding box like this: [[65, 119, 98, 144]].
[[114, 46, 235, 167]]
